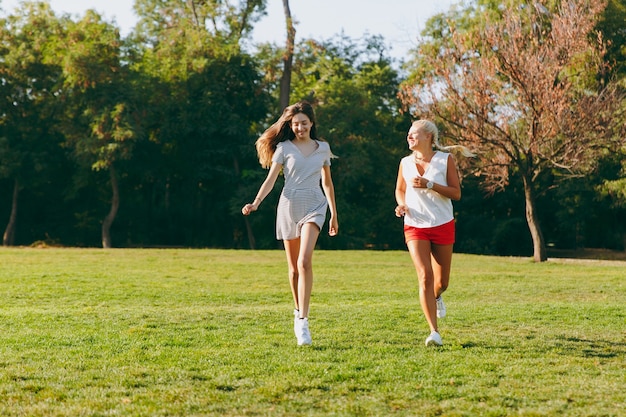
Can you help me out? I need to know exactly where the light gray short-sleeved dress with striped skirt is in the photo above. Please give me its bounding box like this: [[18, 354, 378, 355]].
[[272, 140, 332, 240]]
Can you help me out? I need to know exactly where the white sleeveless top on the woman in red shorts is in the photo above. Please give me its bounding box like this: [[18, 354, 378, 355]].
[[400, 151, 454, 228]]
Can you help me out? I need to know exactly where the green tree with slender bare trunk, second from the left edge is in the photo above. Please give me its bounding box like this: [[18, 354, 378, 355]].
[[59, 10, 139, 248]]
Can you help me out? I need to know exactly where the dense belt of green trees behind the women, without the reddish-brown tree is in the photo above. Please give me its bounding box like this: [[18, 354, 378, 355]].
[[0, 0, 626, 250]]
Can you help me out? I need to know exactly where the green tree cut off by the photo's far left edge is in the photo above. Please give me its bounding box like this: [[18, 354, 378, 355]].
[[0, 2, 61, 245]]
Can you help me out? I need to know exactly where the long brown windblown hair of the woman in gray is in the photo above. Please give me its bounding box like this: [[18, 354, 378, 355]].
[[255, 101, 317, 168]]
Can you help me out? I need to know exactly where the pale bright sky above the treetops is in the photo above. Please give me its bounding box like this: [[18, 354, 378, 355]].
[[0, 0, 459, 59]]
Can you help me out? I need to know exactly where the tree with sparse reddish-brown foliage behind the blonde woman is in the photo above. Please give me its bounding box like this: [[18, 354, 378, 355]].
[[402, 0, 623, 262]]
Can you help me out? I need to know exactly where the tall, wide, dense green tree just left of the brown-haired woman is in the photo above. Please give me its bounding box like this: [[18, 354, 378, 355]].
[[135, 0, 269, 247]]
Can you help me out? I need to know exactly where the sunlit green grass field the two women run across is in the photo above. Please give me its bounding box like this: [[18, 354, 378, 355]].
[[0, 248, 626, 417]]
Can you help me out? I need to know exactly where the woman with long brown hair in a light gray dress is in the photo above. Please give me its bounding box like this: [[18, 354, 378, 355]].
[[241, 101, 339, 346]]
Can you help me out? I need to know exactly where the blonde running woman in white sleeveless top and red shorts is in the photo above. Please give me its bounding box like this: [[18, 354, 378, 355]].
[[395, 120, 472, 346]]
